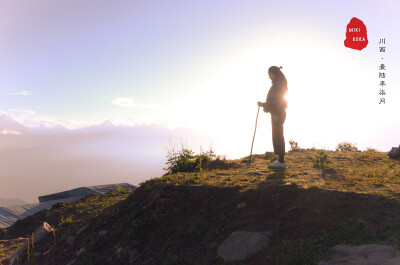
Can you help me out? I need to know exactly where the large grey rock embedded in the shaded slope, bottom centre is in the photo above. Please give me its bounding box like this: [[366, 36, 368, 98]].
[[217, 231, 272, 262]]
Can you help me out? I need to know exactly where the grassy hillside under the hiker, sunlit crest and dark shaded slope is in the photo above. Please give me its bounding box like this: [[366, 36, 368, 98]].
[[0, 150, 400, 264]]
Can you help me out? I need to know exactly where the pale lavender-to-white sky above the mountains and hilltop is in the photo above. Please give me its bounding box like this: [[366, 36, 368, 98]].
[[0, 0, 400, 200]]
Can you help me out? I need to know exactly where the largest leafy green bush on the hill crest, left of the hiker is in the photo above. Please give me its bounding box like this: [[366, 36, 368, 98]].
[[164, 140, 216, 174]]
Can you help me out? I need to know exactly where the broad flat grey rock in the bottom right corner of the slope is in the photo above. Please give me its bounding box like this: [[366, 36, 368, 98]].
[[318, 244, 400, 265]]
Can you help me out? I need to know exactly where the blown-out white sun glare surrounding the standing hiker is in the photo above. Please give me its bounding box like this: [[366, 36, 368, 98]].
[[176, 31, 382, 157]]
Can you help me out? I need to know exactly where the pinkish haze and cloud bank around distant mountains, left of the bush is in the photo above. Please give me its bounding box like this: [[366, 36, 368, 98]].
[[0, 113, 209, 202]]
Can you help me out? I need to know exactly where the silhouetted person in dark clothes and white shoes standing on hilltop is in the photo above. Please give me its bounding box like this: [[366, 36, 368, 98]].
[[257, 66, 288, 168]]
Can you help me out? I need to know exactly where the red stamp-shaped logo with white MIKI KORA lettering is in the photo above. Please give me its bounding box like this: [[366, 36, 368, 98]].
[[344, 17, 368, 51]]
